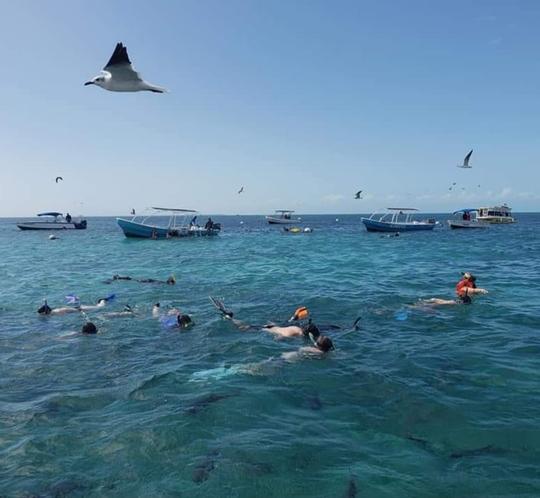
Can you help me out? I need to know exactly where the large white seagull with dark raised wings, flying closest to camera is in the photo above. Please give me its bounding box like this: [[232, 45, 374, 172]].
[[85, 43, 166, 93]]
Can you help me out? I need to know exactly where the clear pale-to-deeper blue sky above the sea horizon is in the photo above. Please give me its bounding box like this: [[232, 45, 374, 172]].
[[0, 0, 540, 216]]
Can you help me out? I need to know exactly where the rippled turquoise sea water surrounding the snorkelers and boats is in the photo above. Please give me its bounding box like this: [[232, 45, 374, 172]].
[[0, 214, 540, 498]]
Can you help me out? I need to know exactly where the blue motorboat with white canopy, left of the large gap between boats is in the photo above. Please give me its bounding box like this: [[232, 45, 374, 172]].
[[116, 207, 221, 239]]
